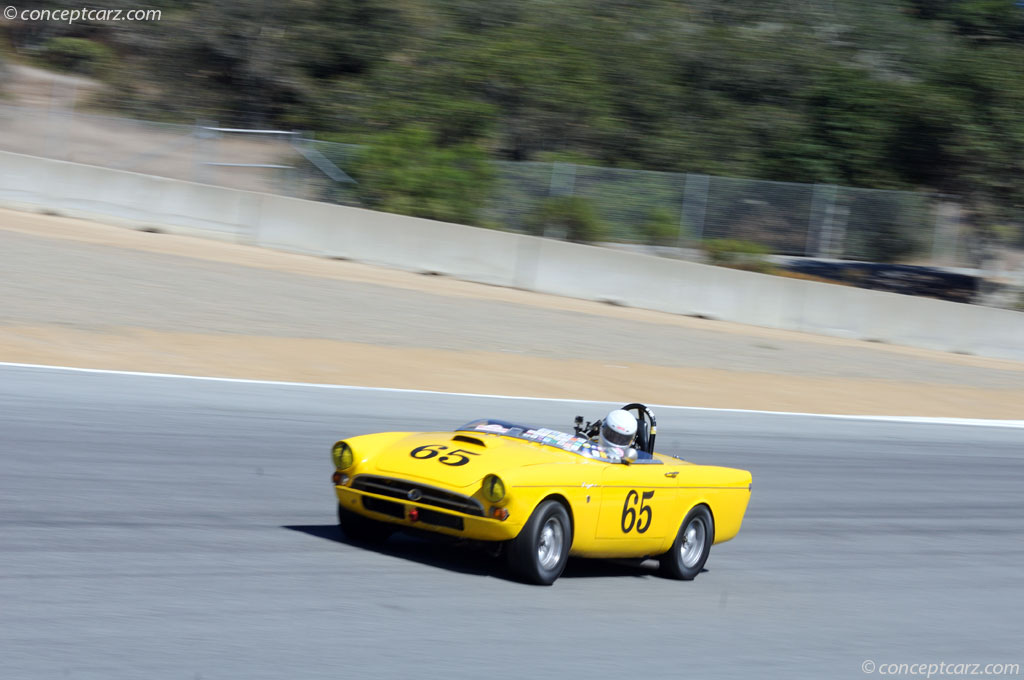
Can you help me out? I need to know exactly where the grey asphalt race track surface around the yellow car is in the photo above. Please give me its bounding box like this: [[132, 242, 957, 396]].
[[0, 367, 1024, 680]]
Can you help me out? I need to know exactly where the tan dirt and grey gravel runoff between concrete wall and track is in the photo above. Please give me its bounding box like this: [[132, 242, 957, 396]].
[[0, 211, 1024, 419]]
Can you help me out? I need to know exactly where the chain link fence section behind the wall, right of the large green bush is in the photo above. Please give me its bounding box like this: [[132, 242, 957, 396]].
[[483, 163, 967, 265]]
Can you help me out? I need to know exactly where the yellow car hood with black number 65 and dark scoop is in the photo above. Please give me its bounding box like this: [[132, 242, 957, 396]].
[[368, 432, 575, 488]]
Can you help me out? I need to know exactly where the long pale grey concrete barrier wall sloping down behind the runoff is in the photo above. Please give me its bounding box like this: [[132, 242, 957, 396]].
[[0, 148, 1024, 360]]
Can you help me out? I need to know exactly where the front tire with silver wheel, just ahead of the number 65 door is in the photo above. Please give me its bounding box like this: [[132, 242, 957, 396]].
[[505, 501, 572, 586]]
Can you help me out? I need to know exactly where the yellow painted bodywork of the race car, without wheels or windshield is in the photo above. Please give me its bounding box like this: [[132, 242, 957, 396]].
[[335, 431, 751, 557]]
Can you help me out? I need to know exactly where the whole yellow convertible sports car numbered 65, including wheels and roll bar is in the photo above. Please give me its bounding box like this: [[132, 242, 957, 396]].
[[332, 403, 751, 585]]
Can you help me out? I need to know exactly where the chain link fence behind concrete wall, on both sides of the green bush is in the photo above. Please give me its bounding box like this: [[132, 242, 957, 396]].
[[0, 105, 977, 266]]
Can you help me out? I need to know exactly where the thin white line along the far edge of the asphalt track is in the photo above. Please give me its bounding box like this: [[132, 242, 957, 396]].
[[6, 362, 1024, 429]]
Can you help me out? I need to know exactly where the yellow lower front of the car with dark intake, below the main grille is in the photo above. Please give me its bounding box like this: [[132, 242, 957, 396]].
[[334, 485, 522, 541]]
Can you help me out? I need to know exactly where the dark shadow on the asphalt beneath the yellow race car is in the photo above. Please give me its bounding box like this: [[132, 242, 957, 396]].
[[282, 524, 679, 583]]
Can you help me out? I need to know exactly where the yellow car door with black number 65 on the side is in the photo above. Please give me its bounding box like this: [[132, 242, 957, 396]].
[[597, 463, 679, 548]]
